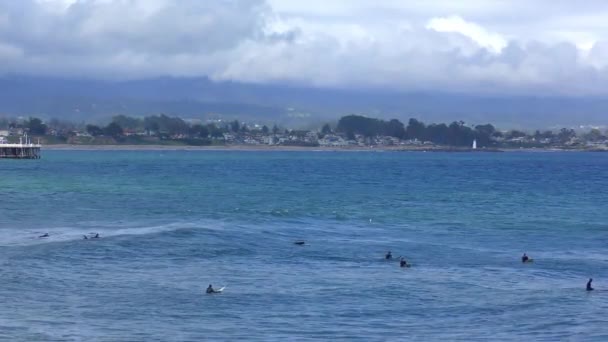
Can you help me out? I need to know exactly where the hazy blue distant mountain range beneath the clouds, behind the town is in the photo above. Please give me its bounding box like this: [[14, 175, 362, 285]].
[[0, 75, 608, 128]]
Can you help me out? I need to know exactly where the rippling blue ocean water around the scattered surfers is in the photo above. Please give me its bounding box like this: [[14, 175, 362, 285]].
[[0, 151, 608, 341]]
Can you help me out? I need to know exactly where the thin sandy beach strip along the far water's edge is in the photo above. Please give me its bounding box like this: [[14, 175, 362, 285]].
[[42, 144, 608, 153]]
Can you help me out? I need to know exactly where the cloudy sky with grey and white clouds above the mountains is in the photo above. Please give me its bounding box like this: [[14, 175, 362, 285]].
[[0, 0, 608, 96]]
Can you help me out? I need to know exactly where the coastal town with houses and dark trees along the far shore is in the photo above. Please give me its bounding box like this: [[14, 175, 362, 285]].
[[0, 114, 608, 151]]
